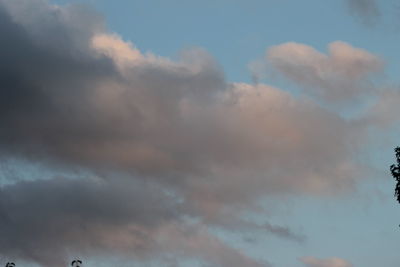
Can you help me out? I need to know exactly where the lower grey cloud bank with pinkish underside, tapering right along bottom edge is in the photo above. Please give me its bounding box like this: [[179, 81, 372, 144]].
[[0, 177, 268, 267]]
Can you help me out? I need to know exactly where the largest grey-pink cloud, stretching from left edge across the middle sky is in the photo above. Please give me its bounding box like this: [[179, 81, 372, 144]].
[[0, 0, 358, 198]]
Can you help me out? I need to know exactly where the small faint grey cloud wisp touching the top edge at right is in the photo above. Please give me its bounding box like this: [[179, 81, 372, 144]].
[[346, 0, 381, 26]]
